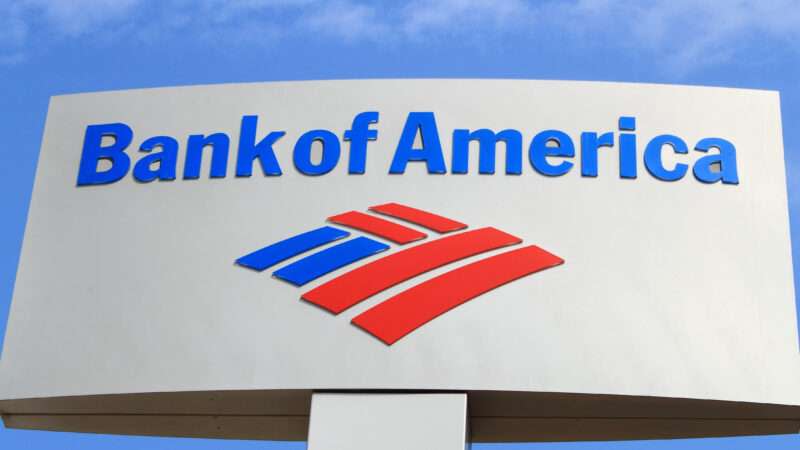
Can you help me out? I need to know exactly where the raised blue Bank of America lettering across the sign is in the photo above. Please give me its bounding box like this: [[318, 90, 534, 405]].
[[78, 111, 739, 185]]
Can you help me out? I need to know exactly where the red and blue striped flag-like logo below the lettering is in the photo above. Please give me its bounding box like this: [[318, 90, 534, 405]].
[[236, 203, 564, 345]]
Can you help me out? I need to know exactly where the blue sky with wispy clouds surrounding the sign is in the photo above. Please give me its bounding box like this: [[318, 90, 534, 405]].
[[0, 0, 800, 450]]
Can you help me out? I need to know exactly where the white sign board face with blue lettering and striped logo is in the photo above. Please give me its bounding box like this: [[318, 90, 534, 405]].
[[0, 80, 800, 442]]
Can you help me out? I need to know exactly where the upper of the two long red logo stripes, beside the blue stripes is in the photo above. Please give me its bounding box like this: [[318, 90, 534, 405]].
[[303, 228, 522, 314]]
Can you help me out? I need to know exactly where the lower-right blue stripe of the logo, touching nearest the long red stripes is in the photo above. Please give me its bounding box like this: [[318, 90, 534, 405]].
[[273, 237, 389, 286]]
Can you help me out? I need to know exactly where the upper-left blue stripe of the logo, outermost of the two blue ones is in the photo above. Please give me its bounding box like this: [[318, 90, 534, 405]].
[[236, 227, 350, 272]]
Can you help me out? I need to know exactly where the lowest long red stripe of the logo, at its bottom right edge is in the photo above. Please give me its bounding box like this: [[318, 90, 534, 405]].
[[352, 245, 564, 345]]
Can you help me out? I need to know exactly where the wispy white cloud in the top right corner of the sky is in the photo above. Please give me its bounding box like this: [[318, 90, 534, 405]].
[[560, 0, 800, 72]]
